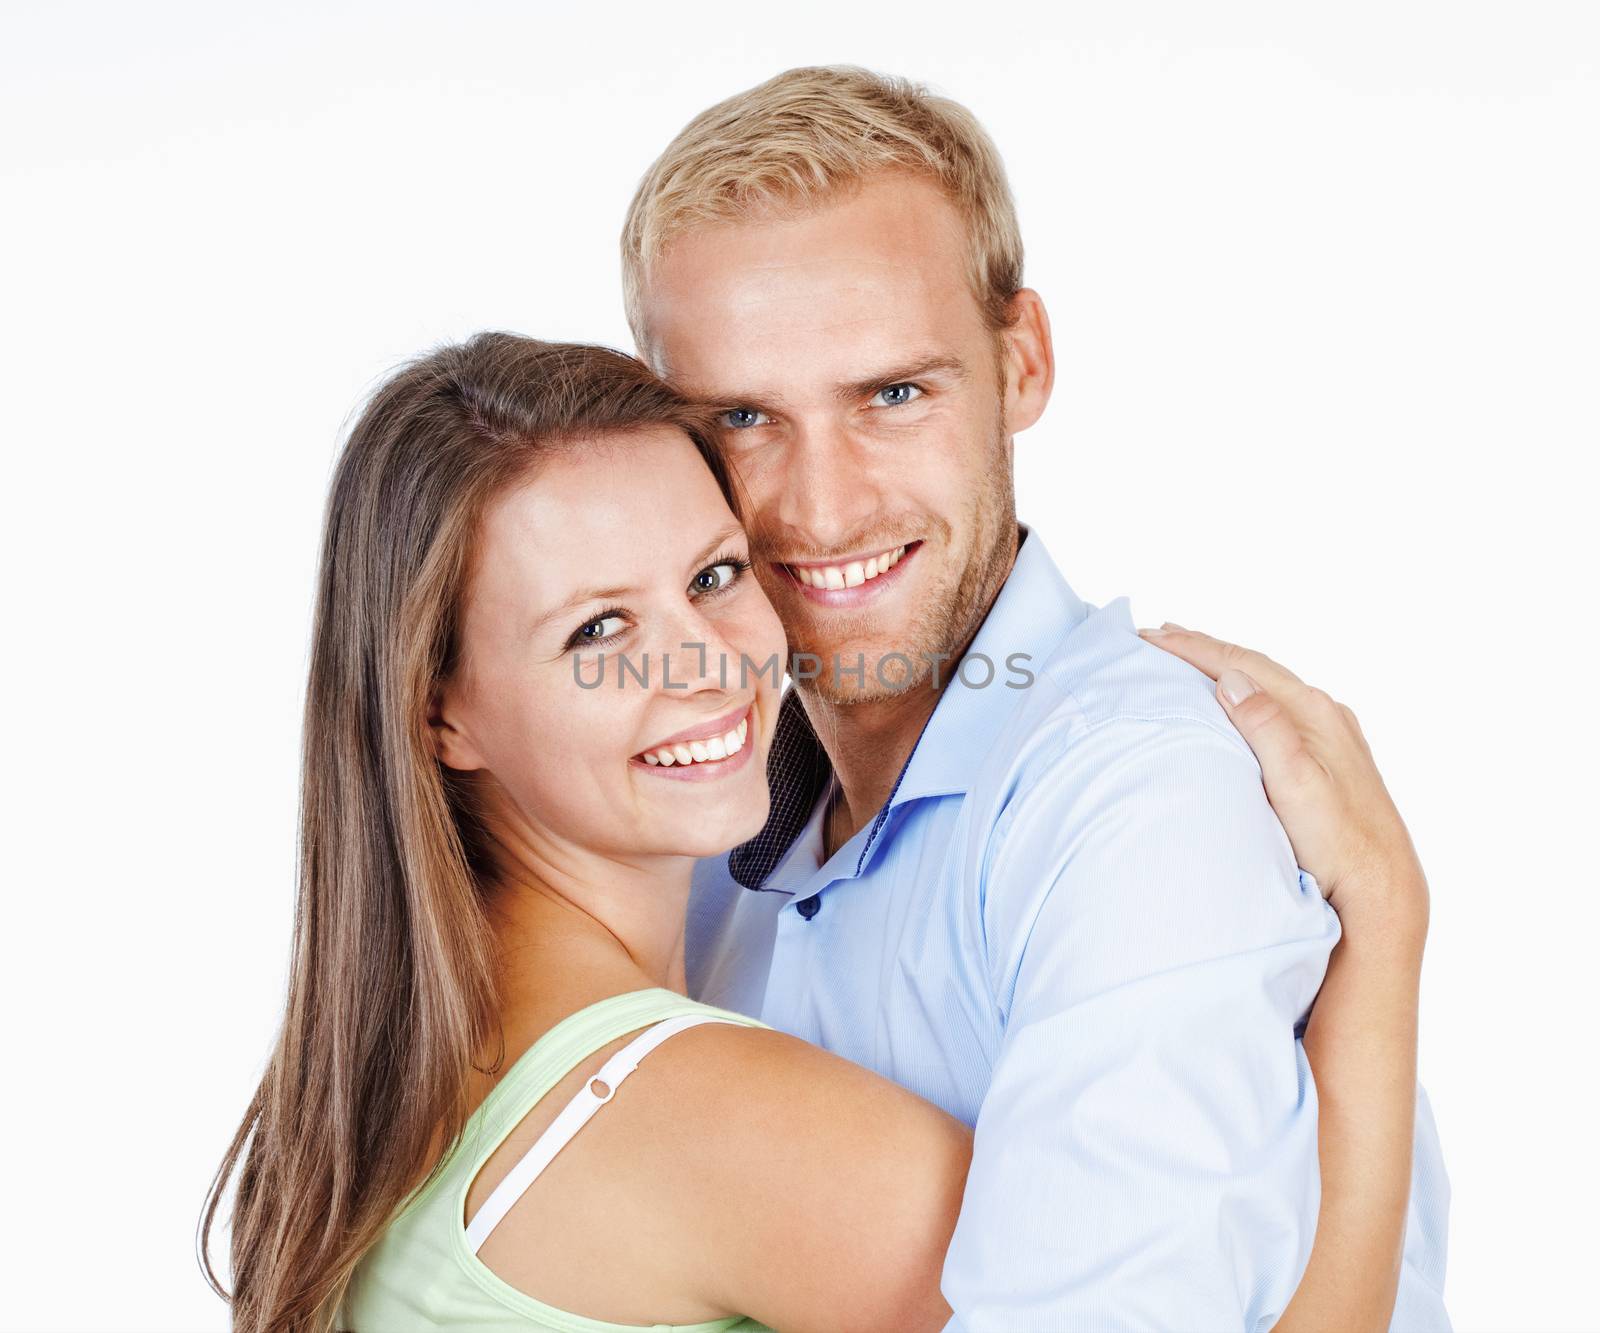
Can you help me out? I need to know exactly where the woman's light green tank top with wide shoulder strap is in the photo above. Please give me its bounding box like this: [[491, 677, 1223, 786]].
[[334, 991, 770, 1333]]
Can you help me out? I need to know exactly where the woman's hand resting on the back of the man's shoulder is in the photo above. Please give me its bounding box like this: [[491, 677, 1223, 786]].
[[1139, 622, 1427, 931]]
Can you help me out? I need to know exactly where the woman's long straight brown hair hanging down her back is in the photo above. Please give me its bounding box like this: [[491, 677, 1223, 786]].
[[200, 333, 734, 1333]]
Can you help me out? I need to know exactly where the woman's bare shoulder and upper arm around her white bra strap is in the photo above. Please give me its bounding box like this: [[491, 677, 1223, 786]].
[[475, 1023, 971, 1333]]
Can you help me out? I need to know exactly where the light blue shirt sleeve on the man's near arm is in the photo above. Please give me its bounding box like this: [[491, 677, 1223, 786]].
[[944, 719, 1339, 1333]]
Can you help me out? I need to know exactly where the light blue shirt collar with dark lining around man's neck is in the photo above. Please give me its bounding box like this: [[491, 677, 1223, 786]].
[[728, 523, 1090, 888]]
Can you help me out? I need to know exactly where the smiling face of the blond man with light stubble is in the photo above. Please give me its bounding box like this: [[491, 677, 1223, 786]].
[[642, 173, 1048, 703]]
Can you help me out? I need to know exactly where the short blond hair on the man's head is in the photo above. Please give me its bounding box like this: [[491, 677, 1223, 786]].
[[622, 66, 1022, 347]]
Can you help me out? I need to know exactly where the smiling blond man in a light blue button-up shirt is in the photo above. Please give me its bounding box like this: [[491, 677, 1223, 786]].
[[622, 69, 1448, 1330]]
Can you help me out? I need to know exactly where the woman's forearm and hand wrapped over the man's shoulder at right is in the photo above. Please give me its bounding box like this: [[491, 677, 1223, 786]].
[[1142, 626, 1429, 1333]]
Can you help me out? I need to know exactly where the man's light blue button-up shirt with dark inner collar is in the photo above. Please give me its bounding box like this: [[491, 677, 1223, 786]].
[[686, 528, 1450, 1333]]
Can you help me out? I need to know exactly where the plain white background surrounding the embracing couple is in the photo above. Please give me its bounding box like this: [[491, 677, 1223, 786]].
[[0, 0, 1600, 1333]]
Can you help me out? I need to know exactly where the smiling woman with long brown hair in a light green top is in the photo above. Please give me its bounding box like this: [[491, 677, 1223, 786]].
[[196, 334, 1426, 1333]]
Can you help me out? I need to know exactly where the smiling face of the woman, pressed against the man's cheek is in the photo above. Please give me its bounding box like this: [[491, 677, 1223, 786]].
[[434, 427, 786, 871]]
